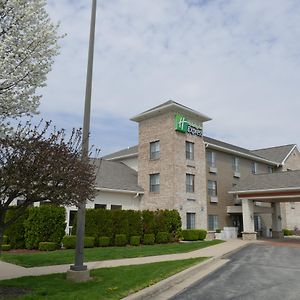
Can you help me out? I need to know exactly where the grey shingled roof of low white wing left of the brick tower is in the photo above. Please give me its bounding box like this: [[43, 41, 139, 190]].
[[96, 159, 143, 192]]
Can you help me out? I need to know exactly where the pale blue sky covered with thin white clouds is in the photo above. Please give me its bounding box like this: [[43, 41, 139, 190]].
[[39, 0, 300, 155]]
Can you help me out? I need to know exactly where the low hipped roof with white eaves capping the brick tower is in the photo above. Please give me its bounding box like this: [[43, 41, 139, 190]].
[[130, 100, 211, 122]]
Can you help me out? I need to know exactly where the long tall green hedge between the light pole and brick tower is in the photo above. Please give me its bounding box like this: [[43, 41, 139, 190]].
[[72, 209, 181, 246]]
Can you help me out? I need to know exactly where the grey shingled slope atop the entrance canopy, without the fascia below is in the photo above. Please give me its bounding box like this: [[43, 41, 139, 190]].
[[231, 170, 300, 192]]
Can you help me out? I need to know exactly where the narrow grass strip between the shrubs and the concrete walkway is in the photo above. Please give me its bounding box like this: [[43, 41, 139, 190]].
[[0, 240, 223, 267]]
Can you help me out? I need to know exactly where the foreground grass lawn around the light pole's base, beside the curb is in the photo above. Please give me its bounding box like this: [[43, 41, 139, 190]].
[[0, 258, 206, 300]]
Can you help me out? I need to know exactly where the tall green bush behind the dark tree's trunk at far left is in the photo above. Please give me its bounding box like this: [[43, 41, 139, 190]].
[[4, 206, 29, 249]]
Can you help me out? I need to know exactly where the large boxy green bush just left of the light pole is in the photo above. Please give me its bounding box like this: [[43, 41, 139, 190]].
[[24, 205, 66, 249]]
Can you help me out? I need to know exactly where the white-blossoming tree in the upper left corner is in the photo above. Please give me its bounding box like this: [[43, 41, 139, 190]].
[[0, 0, 60, 118]]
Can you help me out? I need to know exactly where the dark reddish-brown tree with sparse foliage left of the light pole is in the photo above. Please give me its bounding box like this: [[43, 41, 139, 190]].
[[0, 122, 95, 245]]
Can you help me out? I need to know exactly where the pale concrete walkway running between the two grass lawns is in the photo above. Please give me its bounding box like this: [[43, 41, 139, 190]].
[[0, 240, 249, 280]]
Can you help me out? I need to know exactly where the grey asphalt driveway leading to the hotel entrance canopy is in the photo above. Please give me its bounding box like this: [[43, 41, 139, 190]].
[[171, 241, 300, 300]]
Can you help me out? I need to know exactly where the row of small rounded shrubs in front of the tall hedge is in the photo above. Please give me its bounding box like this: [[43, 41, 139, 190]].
[[61, 232, 171, 251]]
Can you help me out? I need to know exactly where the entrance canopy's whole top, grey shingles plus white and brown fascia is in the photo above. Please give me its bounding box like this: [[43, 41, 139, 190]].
[[229, 170, 300, 202]]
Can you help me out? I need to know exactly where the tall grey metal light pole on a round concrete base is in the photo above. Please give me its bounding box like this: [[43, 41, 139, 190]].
[[67, 0, 97, 281]]
